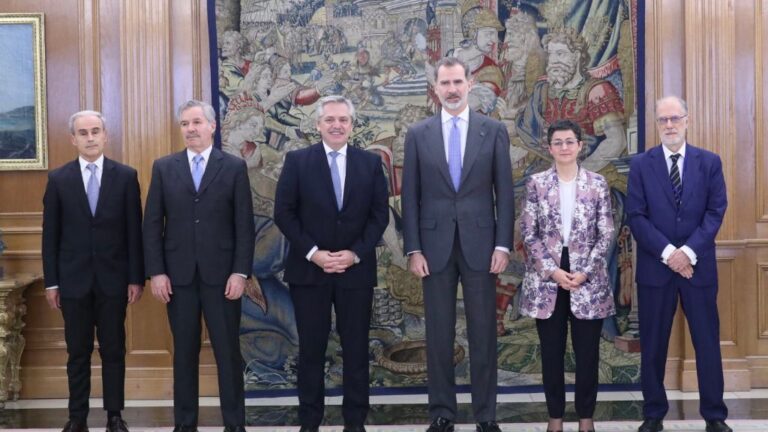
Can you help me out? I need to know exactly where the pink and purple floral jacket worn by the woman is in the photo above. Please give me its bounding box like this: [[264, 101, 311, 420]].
[[520, 168, 616, 319]]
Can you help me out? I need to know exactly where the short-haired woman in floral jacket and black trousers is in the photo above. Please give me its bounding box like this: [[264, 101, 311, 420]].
[[520, 120, 615, 431]]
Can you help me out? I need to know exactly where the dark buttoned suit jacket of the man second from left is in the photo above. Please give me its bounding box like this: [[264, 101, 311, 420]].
[[144, 148, 255, 286]]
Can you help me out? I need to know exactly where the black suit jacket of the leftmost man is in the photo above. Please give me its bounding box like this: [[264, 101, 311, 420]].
[[43, 158, 144, 298]]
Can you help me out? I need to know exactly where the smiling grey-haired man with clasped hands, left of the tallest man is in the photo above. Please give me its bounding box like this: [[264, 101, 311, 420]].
[[275, 96, 389, 432]]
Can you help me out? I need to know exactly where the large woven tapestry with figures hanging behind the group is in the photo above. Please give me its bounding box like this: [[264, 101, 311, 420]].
[[209, 0, 642, 393]]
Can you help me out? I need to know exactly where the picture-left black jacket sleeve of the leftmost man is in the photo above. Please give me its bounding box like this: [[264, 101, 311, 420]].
[[42, 175, 61, 287]]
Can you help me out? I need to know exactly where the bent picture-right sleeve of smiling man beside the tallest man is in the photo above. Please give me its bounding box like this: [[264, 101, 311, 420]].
[[351, 156, 389, 257]]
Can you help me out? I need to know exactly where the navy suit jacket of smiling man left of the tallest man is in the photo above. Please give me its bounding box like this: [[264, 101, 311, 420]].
[[275, 143, 389, 288]]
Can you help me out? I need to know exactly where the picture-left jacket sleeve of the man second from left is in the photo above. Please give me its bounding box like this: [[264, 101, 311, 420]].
[[144, 161, 165, 277]]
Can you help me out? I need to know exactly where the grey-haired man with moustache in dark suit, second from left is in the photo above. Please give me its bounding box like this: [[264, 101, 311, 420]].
[[144, 100, 255, 432]]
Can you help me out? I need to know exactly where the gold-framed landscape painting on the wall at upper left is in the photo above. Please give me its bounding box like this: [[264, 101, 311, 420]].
[[0, 13, 48, 171]]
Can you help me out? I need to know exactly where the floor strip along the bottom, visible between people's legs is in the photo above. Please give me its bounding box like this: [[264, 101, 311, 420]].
[[0, 389, 768, 432]]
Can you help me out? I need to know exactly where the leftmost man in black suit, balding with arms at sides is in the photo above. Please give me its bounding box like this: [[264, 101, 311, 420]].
[[43, 111, 144, 432]]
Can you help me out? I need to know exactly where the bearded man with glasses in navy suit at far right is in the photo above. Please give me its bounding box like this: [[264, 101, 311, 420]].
[[626, 96, 731, 432]]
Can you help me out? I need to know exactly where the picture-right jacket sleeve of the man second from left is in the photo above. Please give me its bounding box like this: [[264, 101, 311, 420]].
[[232, 160, 256, 276]]
